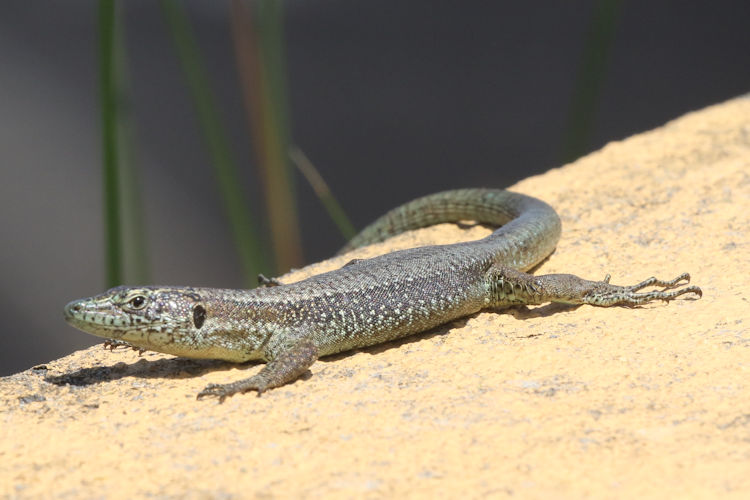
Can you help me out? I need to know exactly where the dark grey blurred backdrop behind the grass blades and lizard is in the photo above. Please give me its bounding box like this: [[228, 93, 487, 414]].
[[0, 0, 750, 375]]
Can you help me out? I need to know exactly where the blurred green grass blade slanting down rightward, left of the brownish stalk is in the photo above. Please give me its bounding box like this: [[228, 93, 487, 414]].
[[161, 0, 268, 284]]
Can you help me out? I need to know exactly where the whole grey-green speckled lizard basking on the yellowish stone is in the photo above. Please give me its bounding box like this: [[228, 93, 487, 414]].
[[64, 189, 703, 402]]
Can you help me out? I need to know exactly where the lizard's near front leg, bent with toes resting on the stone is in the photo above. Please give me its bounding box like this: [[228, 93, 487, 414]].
[[197, 330, 318, 403]]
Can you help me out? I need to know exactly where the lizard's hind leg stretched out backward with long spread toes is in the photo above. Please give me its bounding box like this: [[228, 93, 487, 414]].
[[487, 266, 703, 307]]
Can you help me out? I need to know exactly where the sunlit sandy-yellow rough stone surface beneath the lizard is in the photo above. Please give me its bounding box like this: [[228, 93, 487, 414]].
[[0, 98, 750, 498]]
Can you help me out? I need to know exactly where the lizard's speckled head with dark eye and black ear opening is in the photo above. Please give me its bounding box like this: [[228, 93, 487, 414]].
[[65, 286, 206, 352]]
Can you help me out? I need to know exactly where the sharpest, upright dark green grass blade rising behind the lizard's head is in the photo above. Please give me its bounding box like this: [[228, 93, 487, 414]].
[[98, 0, 122, 287]]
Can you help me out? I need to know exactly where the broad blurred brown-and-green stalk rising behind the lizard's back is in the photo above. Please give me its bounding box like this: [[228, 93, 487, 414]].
[[232, 0, 302, 271]]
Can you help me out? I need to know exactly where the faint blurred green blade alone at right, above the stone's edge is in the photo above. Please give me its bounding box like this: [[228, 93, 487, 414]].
[[562, 0, 620, 163]]
